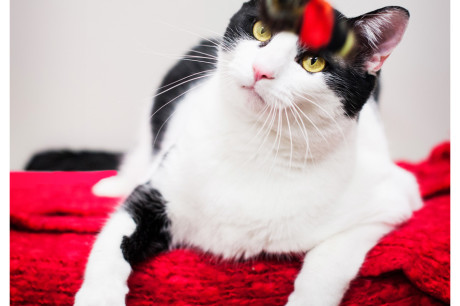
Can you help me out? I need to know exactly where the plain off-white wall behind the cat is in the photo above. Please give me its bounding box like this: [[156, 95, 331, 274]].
[[10, 0, 450, 169]]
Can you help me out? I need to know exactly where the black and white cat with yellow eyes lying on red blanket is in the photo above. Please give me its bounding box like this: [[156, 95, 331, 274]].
[[75, 0, 422, 306]]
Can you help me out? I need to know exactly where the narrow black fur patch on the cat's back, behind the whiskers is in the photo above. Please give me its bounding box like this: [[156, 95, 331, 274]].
[[150, 40, 219, 151]]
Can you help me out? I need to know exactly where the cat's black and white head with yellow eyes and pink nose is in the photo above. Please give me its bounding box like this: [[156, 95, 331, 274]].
[[219, 0, 409, 120]]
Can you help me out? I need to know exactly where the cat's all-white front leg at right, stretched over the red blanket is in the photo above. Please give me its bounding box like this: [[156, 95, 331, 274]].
[[287, 224, 393, 306]]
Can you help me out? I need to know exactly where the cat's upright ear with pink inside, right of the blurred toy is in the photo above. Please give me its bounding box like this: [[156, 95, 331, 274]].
[[350, 6, 409, 74]]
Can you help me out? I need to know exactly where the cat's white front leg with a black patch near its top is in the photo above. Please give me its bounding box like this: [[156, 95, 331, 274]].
[[75, 183, 171, 306]]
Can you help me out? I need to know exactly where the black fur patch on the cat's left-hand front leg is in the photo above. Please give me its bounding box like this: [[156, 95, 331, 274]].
[[121, 183, 171, 265]]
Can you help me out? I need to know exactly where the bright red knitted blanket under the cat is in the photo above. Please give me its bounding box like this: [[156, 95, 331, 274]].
[[10, 143, 450, 305]]
